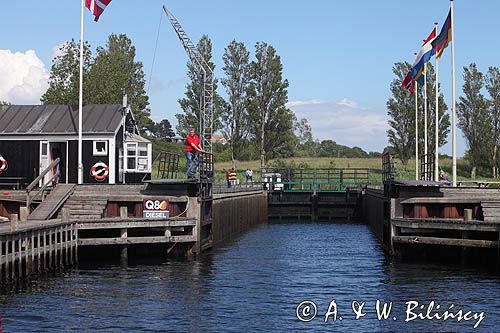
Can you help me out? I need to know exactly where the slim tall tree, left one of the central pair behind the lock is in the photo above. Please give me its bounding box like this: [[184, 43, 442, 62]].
[[221, 40, 250, 165]]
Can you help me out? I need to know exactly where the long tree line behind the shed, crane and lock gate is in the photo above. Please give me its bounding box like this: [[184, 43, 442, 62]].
[[41, 34, 379, 165]]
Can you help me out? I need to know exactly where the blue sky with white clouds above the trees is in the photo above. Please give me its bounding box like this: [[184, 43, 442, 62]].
[[0, 0, 500, 156]]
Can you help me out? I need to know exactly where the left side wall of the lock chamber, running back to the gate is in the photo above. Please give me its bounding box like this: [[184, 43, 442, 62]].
[[212, 191, 267, 244]]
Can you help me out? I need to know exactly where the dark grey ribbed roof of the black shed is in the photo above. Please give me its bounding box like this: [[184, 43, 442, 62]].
[[0, 104, 122, 135]]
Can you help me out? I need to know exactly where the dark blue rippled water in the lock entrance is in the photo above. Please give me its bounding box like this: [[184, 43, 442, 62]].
[[0, 224, 500, 332]]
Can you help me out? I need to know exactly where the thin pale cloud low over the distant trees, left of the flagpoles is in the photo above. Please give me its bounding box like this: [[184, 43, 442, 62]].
[[291, 99, 389, 151]]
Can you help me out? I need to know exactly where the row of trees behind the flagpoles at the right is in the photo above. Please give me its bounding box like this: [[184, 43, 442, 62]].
[[387, 62, 500, 178]]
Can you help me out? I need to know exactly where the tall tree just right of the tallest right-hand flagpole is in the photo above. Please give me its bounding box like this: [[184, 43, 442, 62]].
[[457, 63, 493, 178]]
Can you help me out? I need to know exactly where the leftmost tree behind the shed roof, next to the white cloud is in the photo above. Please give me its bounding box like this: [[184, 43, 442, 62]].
[[40, 40, 92, 105]]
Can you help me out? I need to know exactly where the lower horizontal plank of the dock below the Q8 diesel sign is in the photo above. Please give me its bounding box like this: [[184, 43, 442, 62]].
[[78, 235, 196, 246]]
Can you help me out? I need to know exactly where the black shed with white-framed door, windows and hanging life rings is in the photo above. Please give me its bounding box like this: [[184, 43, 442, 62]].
[[0, 104, 152, 186]]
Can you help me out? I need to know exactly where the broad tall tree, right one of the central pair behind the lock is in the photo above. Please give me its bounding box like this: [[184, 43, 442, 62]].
[[248, 42, 295, 168]]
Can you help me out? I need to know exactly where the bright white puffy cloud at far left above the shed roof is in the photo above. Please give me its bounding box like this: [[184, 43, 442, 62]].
[[0, 50, 49, 104]]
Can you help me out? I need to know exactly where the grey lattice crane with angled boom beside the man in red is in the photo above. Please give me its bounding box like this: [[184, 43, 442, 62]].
[[163, 5, 214, 153]]
